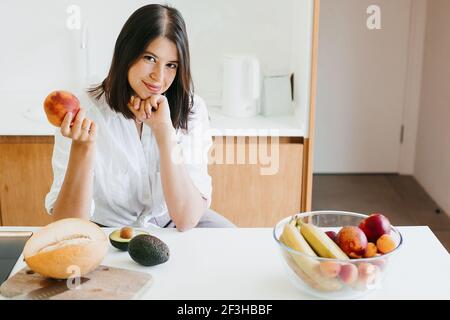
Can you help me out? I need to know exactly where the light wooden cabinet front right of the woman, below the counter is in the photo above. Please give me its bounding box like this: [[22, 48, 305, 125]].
[[209, 137, 303, 227]]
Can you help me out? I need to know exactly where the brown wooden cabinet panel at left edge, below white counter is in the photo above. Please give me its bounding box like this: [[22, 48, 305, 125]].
[[0, 137, 53, 226]]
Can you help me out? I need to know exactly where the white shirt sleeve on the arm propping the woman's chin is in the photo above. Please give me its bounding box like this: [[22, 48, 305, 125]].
[[178, 96, 212, 208]]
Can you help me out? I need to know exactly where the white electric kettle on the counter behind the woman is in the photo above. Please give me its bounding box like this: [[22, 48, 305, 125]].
[[222, 56, 261, 117]]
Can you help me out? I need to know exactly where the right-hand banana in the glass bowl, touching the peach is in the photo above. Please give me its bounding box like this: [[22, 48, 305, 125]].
[[297, 219, 349, 260]]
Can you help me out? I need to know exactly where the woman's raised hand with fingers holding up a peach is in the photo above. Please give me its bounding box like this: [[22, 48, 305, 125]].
[[61, 108, 97, 144]]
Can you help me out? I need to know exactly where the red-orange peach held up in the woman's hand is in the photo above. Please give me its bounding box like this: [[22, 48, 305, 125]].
[[44, 90, 80, 127]]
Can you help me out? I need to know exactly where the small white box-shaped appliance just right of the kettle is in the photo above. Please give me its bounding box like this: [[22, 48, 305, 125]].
[[261, 74, 293, 117]]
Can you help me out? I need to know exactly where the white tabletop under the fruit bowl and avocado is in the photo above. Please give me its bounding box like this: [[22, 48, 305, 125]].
[[0, 226, 450, 300]]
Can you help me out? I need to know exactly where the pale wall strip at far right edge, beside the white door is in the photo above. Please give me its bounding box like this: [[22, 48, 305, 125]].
[[415, 0, 450, 214]]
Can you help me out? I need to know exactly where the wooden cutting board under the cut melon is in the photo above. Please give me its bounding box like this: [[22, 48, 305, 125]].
[[0, 265, 152, 300]]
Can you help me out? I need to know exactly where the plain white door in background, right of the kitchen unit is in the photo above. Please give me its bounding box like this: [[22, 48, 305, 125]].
[[314, 0, 411, 173]]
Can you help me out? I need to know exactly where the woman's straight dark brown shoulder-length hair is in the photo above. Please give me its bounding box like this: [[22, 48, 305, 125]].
[[88, 4, 194, 130]]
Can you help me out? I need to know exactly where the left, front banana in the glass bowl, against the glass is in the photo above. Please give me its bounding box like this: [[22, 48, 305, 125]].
[[280, 220, 342, 291]]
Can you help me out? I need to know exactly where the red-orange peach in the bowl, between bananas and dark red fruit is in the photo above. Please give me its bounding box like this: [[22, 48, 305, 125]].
[[336, 226, 367, 258]]
